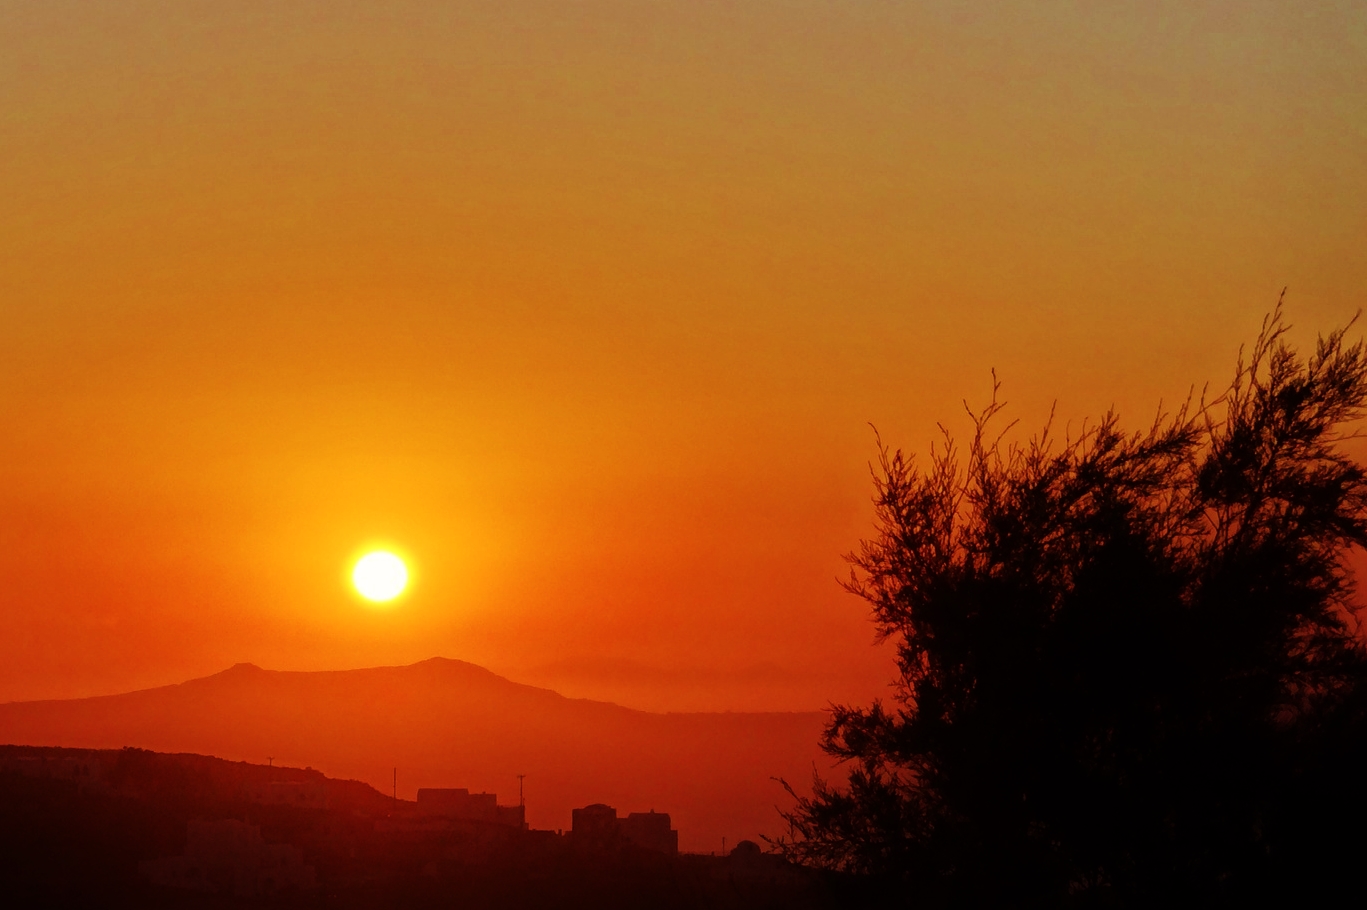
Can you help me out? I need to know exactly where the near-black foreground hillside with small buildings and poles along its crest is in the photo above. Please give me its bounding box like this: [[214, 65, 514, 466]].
[[0, 746, 867, 910]]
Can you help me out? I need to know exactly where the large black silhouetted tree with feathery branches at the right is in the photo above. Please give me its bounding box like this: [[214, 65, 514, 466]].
[[781, 305, 1367, 907]]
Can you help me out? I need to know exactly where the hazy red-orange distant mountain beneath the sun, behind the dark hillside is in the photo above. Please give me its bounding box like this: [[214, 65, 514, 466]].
[[0, 657, 828, 851]]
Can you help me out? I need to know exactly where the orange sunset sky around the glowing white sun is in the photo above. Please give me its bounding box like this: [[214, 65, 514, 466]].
[[0, 0, 1367, 709]]
